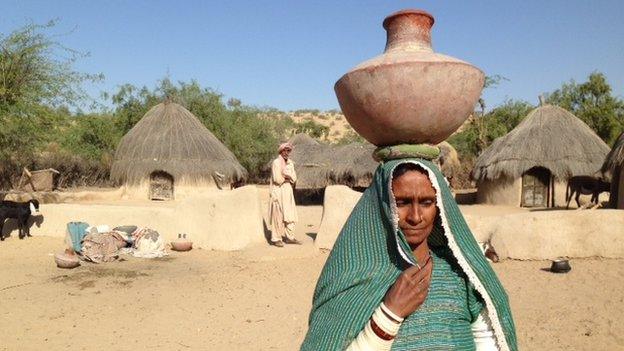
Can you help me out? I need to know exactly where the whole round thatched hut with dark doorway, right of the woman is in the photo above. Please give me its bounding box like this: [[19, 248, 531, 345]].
[[472, 105, 609, 207]]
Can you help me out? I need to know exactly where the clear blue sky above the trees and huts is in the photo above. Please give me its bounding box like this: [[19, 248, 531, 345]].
[[0, 0, 624, 110]]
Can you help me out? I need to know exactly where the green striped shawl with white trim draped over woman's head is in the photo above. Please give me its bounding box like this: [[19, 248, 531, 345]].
[[301, 158, 517, 351]]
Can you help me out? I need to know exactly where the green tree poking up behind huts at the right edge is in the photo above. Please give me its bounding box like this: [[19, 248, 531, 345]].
[[546, 72, 624, 145]]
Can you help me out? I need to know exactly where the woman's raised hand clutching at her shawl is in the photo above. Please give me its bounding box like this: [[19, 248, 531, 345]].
[[384, 260, 433, 318]]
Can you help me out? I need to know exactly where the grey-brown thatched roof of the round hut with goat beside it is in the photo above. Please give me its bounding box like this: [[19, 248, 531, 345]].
[[473, 105, 609, 180]]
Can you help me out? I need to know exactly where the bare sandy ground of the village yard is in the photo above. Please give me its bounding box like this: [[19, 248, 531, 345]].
[[0, 199, 624, 350]]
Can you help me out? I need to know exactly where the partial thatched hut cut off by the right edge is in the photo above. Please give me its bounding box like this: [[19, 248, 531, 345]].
[[600, 132, 624, 209]]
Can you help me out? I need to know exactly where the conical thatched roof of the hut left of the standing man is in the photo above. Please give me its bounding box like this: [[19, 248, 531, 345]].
[[111, 102, 247, 184]]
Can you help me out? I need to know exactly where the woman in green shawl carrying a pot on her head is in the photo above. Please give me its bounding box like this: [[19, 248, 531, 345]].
[[301, 158, 517, 350]]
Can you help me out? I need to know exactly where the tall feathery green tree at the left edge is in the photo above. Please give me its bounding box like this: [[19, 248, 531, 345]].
[[0, 21, 106, 188]]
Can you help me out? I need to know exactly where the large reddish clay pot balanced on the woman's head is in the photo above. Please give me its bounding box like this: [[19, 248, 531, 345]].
[[334, 10, 485, 146]]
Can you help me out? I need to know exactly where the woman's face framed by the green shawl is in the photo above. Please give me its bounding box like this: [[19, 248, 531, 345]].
[[392, 171, 438, 248]]
